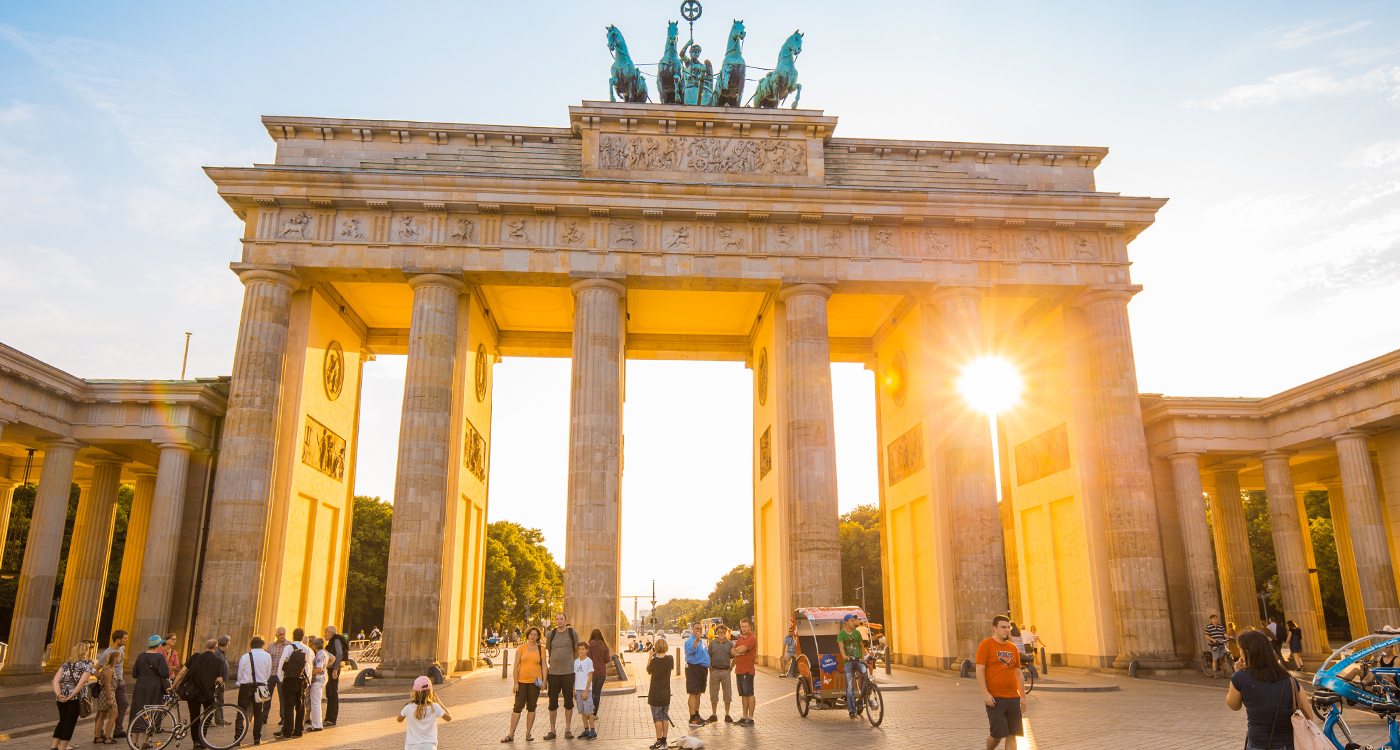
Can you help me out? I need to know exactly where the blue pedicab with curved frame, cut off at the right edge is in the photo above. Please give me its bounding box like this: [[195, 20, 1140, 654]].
[[1309, 630, 1400, 750]]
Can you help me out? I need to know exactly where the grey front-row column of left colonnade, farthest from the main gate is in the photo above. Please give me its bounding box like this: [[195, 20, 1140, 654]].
[[0, 438, 80, 681]]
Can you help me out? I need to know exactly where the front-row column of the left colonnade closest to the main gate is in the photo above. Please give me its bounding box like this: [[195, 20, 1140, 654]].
[[132, 442, 193, 641]]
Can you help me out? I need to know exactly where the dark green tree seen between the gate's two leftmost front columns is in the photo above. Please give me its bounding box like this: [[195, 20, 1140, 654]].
[[343, 495, 393, 632]]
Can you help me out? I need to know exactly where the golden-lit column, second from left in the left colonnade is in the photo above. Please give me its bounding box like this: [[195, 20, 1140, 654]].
[[49, 459, 122, 669]]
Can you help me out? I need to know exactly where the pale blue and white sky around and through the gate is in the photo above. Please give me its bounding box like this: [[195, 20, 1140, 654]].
[[0, 0, 1400, 596]]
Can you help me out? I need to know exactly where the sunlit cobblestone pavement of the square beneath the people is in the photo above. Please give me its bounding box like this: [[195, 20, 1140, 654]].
[[6, 659, 1382, 750]]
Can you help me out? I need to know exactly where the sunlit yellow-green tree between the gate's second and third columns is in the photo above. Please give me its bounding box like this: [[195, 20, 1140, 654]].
[[482, 521, 564, 631]]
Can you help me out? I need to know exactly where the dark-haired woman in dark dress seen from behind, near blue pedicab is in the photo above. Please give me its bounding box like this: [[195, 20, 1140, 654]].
[[1225, 632, 1315, 750]]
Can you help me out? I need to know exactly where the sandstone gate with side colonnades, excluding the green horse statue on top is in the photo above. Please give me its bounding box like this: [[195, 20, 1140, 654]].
[[0, 102, 1400, 679]]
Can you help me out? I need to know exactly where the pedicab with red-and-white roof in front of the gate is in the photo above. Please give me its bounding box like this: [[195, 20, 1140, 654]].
[[792, 607, 885, 726]]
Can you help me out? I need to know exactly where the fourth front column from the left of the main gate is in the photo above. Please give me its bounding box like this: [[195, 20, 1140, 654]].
[[778, 284, 841, 610]]
